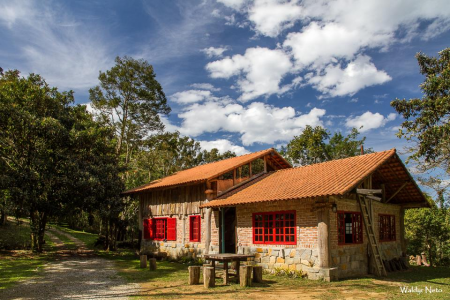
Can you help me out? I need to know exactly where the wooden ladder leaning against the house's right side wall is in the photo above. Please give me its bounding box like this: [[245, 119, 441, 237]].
[[356, 194, 387, 277]]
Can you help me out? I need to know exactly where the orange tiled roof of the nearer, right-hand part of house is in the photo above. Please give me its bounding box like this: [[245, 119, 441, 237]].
[[202, 149, 426, 207]]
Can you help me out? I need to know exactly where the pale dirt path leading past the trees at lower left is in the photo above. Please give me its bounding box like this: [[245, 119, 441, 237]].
[[0, 228, 140, 300]]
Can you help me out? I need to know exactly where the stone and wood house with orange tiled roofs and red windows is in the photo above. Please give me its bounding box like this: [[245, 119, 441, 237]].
[[124, 149, 430, 280]]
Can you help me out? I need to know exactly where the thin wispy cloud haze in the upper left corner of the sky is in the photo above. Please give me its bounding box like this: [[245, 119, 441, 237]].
[[0, 1, 113, 90]]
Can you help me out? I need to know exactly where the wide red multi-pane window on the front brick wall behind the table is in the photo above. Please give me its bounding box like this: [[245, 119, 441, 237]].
[[252, 210, 297, 245]]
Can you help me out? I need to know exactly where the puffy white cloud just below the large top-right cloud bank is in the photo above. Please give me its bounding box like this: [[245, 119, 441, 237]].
[[309, 55, 391, 97]]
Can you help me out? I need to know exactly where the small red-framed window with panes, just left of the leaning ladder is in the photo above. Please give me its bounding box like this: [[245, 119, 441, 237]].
[[338, 212, 363, 245]]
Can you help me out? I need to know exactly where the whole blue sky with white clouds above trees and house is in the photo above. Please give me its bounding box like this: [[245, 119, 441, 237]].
[[0, 0, 450, 154]]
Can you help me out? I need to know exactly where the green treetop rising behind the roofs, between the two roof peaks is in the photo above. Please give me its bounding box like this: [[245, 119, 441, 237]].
[[280, 125, 372, 165]]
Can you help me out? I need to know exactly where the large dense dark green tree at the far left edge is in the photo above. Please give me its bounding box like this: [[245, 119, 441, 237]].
[[0, 71, 73, 251]]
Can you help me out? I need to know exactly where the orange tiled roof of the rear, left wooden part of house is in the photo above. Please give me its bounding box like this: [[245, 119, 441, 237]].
[[122, 148, 291, 194]]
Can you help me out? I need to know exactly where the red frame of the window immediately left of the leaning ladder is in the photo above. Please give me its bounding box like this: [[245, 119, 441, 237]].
[[337, 211, 363, 245]]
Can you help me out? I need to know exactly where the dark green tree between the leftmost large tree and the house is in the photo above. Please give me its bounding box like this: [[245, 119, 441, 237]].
[[64, 106, 125, 250]]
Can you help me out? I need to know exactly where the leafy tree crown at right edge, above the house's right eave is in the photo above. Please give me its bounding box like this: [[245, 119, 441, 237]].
[[391, 48, 450, 168]]
